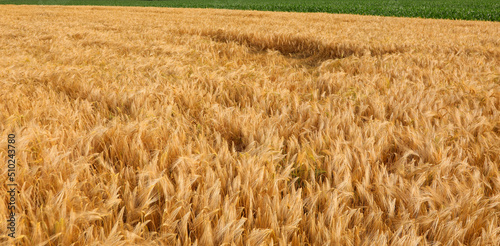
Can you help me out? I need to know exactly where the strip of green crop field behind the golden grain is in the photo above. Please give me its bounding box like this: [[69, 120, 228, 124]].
[[0, 0, 500, 21]]
